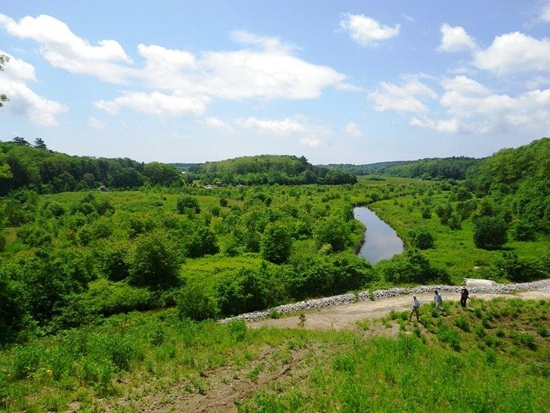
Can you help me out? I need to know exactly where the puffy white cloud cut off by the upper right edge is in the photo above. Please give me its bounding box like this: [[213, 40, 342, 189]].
[[474, 32, 550, 75]]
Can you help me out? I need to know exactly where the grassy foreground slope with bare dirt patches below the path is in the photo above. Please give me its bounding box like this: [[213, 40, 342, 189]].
[[0, 299, 550, 412]]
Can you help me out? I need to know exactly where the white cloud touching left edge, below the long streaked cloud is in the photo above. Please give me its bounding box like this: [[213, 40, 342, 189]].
[[0, 50, 68, 126]]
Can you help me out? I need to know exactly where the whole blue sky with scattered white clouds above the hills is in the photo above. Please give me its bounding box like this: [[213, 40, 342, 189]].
[[0, 0, 550, 164]]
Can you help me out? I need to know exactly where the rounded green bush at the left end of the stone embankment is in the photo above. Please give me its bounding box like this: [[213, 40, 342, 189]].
[[176, 284, 219, 321]]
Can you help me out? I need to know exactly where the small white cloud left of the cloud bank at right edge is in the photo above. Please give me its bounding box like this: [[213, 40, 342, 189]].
[[368, 79, 437, 113]]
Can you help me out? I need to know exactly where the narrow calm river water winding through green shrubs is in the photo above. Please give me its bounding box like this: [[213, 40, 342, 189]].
[[353, 207, 405, 264]]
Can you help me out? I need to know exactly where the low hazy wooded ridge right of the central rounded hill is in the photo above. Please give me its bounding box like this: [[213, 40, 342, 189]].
[[326, 156, 481, 180]]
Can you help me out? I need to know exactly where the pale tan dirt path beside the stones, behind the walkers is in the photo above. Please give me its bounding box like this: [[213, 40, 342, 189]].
[[249, 291, 550, 330]]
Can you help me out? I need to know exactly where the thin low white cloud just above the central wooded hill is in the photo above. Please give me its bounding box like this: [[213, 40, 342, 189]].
[[235, 115, 332, 147]]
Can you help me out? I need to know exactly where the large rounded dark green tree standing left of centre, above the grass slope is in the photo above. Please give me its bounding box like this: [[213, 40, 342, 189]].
[[129, 231, 180, 287]]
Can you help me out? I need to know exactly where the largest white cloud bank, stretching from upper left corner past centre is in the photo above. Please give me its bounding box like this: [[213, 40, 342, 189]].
[[0, 14, 346, 116]]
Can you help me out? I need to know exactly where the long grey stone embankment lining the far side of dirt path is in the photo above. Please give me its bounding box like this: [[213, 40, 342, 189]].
[[221, 279, 550, 323]]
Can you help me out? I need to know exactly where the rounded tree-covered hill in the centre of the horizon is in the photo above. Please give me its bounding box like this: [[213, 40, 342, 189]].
[[179, 155, 357, 185]]
